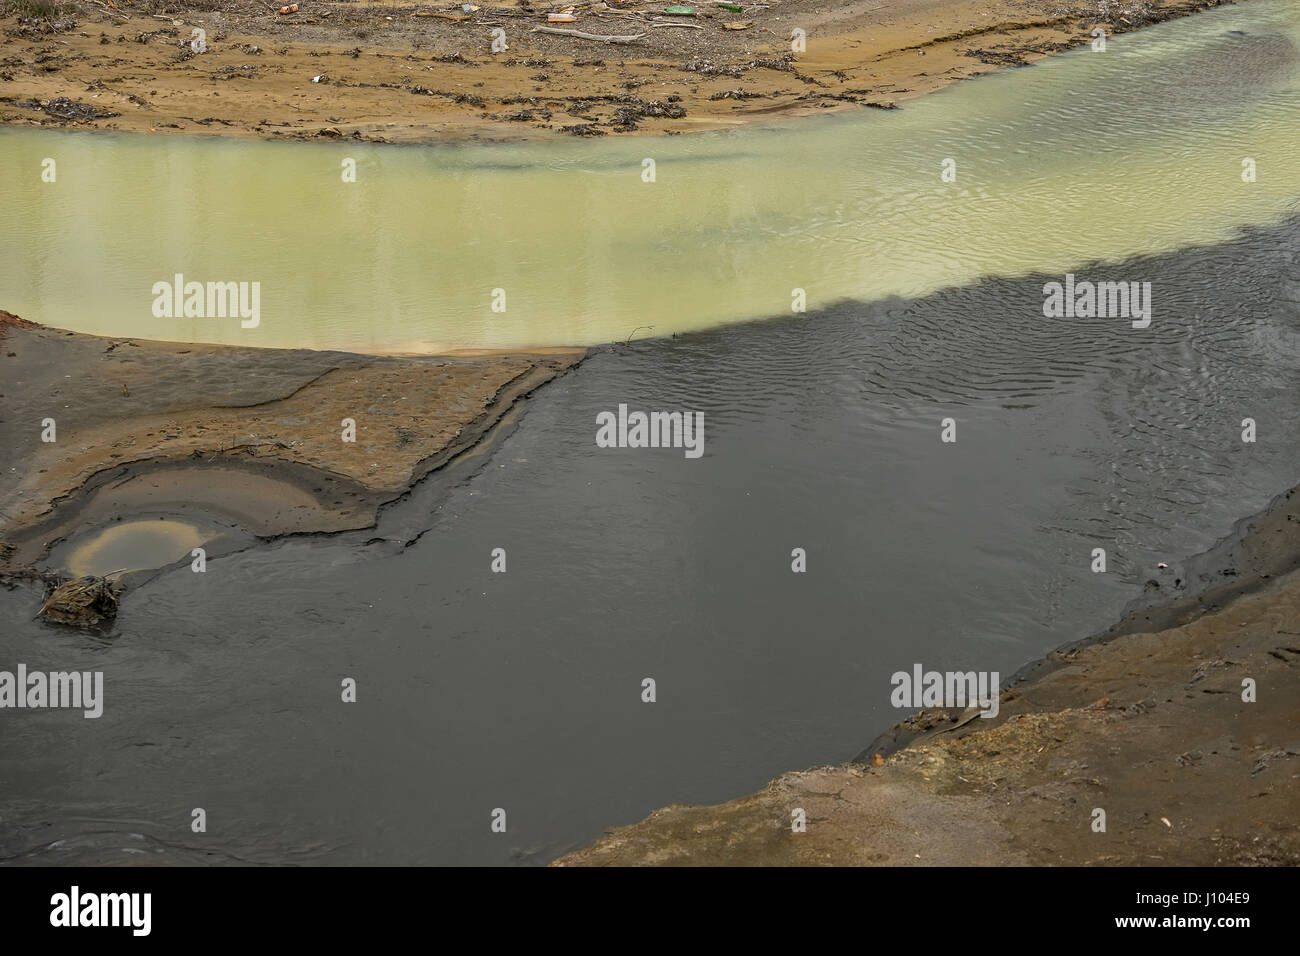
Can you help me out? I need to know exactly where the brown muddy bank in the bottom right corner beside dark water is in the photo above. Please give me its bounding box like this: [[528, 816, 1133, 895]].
[[555, 489, 1300, 866]]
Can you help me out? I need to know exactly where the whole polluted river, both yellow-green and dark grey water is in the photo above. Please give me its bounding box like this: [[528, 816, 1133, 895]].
[[0, 0, 1300, 865]]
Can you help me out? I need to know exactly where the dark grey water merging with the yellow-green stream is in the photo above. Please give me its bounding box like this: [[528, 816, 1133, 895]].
[[0, 209, 1300, 864]]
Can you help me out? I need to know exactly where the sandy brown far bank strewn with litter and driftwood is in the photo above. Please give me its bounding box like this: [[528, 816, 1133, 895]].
[[0, 0, 1219, 142]]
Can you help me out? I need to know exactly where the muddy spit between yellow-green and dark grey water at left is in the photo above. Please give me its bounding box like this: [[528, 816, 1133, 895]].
[[0, 312, 584, 568]]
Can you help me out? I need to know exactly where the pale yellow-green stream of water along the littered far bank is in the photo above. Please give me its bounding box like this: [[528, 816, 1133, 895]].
[[0, 0, 1300, 351]]
